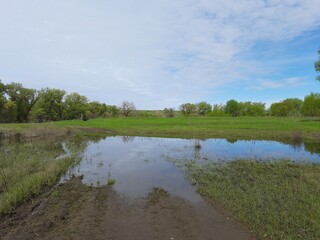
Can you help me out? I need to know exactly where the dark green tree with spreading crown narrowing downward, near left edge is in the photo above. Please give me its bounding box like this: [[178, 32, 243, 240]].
[[6, 83, 40, 122]]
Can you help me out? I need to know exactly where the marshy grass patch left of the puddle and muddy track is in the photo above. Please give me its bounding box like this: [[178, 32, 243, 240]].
[[0, 141, 77, 214]]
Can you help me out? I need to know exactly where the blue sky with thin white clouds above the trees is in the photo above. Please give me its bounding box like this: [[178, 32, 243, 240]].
[[0, 0, 320, 110]]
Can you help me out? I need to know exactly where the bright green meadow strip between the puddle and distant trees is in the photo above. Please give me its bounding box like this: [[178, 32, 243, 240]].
[[52, 117, 320, 140]]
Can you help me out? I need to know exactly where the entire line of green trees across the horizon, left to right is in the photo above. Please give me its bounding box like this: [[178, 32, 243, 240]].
[[0, 80, 320, 123]]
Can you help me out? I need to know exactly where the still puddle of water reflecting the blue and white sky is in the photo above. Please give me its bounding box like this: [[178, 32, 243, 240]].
[[62, 137, 320, 202]]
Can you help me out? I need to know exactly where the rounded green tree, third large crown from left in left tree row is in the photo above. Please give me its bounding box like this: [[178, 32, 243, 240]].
[[64, 92, 88, 120]]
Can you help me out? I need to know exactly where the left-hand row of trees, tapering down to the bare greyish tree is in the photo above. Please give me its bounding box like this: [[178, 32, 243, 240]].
[[0, 80, 135, 123]]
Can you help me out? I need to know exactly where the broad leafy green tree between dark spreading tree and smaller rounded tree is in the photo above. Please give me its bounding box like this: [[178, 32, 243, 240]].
[[31, 88, 66, 122]]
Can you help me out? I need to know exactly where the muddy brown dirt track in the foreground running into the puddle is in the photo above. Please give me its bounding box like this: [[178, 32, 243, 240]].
[[0, 178, 253, 240]]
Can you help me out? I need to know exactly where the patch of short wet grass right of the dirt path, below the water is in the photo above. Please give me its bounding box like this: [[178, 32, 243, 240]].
[[184, 160, 320, 239]]
